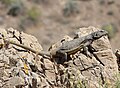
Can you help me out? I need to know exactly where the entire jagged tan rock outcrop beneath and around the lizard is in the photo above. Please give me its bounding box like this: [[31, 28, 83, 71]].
[[0, 27, 118, 88]]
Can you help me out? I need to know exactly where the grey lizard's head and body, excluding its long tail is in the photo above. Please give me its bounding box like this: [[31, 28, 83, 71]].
[[51, 30, 108, 63]]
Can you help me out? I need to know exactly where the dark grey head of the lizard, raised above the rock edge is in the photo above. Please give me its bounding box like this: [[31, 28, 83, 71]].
[[92, 30, 108, 39]]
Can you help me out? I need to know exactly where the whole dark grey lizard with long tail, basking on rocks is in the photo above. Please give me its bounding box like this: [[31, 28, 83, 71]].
[[5, 30, 108, 64]]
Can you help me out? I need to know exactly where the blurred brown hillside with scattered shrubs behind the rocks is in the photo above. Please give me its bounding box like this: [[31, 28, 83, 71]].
[[0, 0, 120, 49]]
